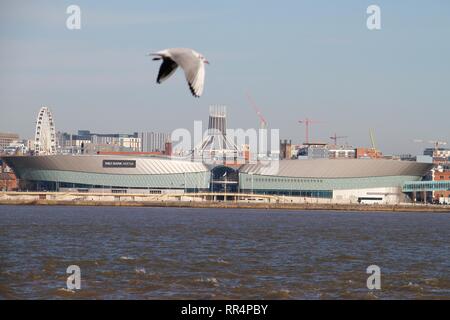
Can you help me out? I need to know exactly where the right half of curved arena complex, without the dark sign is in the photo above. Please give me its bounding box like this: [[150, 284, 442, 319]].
[[239, 159, 432, 203]]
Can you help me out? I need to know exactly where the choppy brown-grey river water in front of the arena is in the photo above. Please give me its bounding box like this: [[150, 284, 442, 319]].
[[0, 206, 450, 299]]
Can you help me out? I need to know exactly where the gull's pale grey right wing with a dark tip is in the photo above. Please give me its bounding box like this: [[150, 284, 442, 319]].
[[171, 49, 205, 98]]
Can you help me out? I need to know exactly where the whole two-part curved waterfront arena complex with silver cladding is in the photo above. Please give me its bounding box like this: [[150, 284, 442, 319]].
[[3, 155, 432, 203]]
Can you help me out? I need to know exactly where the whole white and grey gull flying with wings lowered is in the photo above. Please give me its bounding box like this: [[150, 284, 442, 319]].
[[148, 48, 209, 98]]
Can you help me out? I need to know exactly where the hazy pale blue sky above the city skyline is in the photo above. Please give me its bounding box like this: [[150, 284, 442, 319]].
[[0, 0, 450, 154]]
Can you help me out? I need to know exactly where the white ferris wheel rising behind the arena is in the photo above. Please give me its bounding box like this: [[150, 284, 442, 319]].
[[34, 107, 56, 155]]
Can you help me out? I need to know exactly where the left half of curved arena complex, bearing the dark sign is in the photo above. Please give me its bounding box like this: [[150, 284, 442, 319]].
[[3, 155, 210, 193]]
